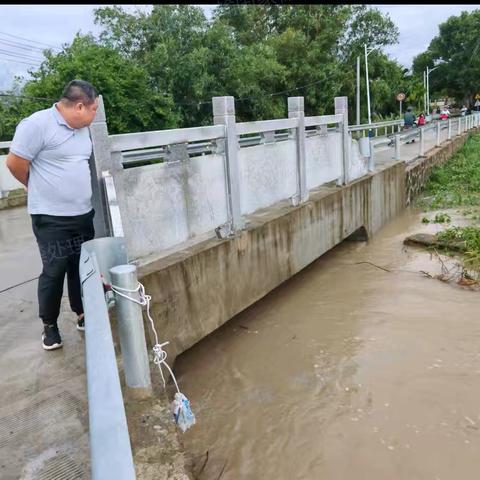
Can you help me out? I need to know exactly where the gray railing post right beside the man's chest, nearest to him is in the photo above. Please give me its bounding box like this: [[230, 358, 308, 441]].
[[89, 95, 114, 238]]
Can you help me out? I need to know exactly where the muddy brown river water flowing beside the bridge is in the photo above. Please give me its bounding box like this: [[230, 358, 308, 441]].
[[176, 210, 480, 480]]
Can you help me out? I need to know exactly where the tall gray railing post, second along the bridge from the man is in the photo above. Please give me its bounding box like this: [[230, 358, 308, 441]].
[[212, 97, 244, 233]]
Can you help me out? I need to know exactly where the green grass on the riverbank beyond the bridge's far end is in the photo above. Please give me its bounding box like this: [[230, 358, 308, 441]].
[[416, 134, 480, 211]]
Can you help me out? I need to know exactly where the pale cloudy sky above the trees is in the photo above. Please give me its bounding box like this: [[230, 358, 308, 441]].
[[0, 4, 480, 91]]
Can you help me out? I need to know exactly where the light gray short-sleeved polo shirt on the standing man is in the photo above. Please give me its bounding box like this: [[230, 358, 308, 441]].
[[10, 104, 92, 216]]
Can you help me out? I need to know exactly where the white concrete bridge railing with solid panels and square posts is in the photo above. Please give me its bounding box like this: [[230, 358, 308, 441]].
[[97, 97, 367, 258]]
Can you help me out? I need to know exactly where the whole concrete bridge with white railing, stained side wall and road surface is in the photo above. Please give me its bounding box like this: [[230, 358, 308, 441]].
[[0, 97, 478, 479]]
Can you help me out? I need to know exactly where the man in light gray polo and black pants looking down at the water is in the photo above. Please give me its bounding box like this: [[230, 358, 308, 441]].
[[7, 80, 98, 350]]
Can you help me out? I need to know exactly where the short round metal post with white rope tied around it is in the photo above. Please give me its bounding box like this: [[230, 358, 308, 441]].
[[110, 265, 152, 399]]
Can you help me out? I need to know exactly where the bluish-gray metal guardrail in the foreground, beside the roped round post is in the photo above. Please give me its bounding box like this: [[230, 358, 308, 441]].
[[80, 237, 136, 480]]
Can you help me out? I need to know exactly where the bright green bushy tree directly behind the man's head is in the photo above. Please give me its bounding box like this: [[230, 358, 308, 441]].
[[19, 35, 178, 134]]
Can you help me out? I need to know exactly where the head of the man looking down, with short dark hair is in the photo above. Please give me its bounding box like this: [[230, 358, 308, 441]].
[[60, 80, 98, 128]]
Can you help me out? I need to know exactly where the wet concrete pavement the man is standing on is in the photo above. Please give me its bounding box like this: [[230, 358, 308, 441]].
[[0, 207, 90, 480]]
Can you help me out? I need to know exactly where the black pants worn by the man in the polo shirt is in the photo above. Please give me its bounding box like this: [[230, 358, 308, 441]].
[[31, 209, 95, 325]]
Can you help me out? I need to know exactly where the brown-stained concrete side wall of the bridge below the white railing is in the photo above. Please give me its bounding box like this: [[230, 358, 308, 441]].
[[139, 129, 476, 357]]
